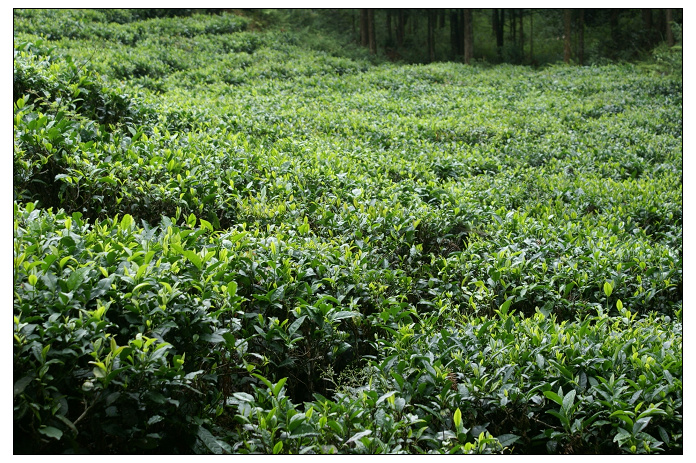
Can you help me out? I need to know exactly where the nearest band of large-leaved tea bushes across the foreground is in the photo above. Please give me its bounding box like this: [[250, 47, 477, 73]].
[[13, 203, 683, 453]]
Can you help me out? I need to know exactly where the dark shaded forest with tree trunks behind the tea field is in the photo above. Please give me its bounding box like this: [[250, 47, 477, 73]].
[[218, 8, 682, 66]]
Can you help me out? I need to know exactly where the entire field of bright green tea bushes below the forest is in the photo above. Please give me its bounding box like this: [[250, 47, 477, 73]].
[[13, 10, 683, 454]]
